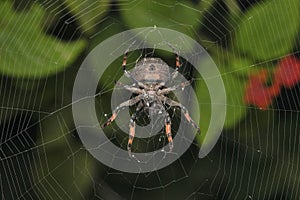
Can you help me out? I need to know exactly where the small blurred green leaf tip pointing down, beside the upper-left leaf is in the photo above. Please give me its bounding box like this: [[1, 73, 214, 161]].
[[64, 0, 110, 34]]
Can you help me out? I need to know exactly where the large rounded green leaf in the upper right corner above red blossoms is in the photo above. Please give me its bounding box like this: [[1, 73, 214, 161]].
[[233, 0, 300, 60]]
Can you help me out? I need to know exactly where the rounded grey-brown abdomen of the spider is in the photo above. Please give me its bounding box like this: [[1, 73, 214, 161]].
[[131, 58, 170, 85]]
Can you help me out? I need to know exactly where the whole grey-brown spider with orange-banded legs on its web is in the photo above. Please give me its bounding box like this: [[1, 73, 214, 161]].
[[102, 51, 200, 156]]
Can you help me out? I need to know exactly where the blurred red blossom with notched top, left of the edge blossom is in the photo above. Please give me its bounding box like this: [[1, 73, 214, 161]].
[[244, 69, 280, 109]]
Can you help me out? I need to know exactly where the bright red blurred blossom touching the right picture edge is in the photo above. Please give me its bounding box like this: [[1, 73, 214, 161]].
[[273, 56, 300, 88]]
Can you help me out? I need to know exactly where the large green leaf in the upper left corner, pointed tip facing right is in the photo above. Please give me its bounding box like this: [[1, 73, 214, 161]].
[[0, 1, 85, 78]]
